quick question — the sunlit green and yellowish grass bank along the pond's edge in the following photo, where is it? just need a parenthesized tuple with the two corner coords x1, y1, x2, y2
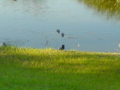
(0, 47, 120, 90)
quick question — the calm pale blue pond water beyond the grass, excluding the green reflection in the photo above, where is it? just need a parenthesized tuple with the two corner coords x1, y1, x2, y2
(0, 0, 120, 52)
